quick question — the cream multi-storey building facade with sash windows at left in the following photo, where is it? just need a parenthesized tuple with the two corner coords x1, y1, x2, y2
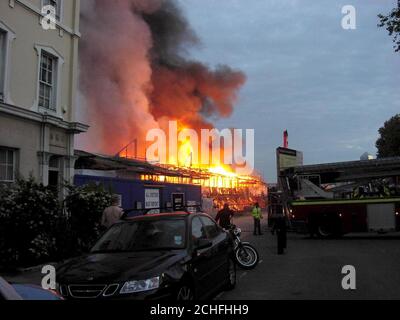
(0, 0, 88, 185)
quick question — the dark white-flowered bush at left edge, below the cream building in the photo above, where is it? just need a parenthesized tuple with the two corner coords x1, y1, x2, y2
(0, 178, 61, 268)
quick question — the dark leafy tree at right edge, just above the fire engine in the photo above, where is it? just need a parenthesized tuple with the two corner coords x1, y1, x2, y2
(376, 114, 400, 158)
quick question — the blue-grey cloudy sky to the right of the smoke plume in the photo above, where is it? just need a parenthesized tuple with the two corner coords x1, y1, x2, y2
(179, 0, 400, 182)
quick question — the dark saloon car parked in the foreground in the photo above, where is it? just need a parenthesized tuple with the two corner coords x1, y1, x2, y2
(57, 212, 236, 300)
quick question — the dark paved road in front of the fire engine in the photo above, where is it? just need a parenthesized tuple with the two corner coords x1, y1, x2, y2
(218, 212, 400, 300)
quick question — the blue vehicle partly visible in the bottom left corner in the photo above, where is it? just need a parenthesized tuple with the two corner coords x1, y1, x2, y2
(0, 277, 63, 301)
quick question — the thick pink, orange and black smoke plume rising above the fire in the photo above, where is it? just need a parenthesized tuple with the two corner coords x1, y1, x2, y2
(80, 0, 245, 157)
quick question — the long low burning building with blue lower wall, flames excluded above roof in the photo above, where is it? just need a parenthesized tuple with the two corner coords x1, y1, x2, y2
(75, 151, 267, 214)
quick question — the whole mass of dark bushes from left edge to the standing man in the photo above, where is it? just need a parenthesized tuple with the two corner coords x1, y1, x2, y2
(0, 178, 112, 270)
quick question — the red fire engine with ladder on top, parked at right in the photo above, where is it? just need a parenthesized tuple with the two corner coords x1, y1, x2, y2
(279, 158, 400, 237)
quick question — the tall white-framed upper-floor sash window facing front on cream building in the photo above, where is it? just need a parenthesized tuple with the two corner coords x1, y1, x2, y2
(39, 51, 57, 111)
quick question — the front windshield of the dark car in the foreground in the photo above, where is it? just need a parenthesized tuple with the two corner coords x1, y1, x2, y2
(91, 218, 186, 253)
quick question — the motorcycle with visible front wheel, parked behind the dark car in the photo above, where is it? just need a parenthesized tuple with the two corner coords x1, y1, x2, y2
(228, 225, 260, 270)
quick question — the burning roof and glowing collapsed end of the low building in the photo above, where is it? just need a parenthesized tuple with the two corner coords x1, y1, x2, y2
(75, 151, 268, 210)
